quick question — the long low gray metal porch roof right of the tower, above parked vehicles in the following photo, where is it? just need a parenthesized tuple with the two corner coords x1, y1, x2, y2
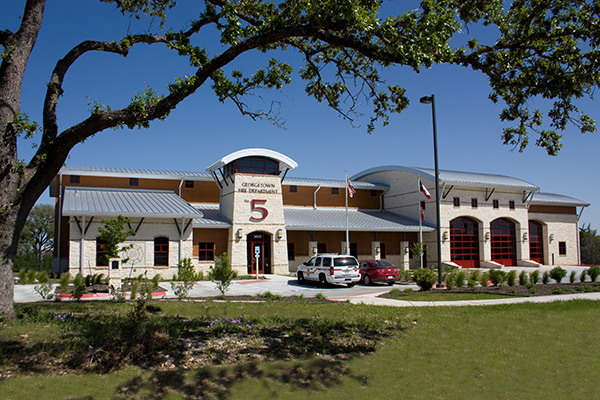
(284, 207, 434, 232)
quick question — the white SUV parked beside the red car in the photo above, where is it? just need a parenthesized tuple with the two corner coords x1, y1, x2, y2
(296, 254, 360, 287)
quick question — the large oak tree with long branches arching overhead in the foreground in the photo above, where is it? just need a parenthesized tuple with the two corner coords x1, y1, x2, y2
(0, 0, 600, 319)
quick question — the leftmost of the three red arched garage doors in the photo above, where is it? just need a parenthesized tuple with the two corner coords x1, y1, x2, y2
(450, 217, 479, 268)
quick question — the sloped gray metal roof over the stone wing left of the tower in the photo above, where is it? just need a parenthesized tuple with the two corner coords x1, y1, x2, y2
(62, 187, 202, 218)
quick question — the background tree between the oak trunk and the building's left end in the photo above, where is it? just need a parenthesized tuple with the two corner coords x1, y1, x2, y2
(14, 204, 54, 272)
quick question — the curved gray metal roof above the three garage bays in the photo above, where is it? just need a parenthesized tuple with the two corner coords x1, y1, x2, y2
(351, 165, 540, 191)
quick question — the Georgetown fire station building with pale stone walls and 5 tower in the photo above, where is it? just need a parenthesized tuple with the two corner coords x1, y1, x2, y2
(50, 149, 589, 277)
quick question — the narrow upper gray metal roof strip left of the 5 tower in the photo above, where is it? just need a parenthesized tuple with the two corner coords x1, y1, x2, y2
(60, 166, 213, 181)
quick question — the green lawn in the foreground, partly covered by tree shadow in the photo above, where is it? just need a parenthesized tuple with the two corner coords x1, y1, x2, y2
(0, 301, 600, 400)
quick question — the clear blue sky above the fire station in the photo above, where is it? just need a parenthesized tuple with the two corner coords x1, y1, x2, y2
(5, 0, 600, 229)
